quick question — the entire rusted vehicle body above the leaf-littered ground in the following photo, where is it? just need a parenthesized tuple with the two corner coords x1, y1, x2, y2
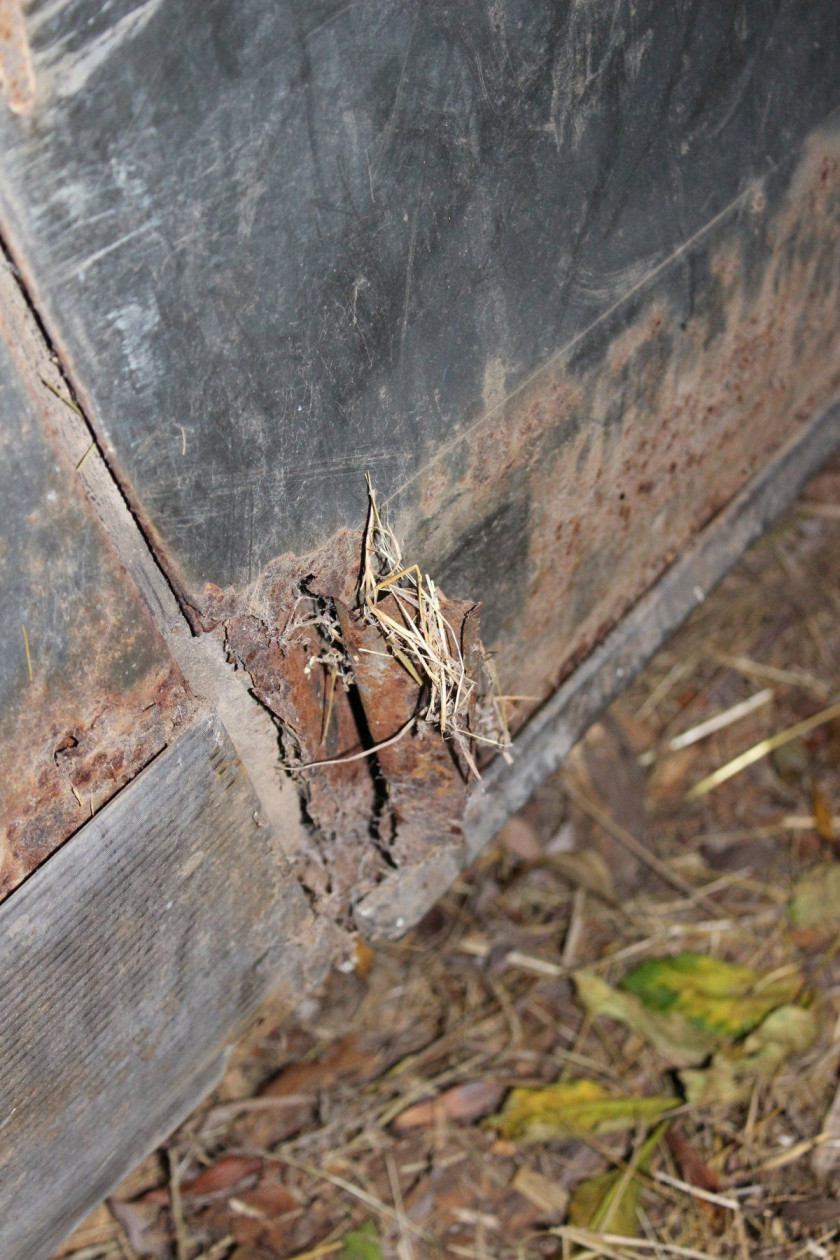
(0, 0, 840, 1260)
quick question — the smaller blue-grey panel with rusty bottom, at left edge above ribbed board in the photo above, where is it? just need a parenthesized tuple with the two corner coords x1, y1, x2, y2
(0, 312, 193, 900)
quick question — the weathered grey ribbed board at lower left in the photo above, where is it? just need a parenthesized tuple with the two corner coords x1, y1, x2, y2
(0, 716, 319, 1260)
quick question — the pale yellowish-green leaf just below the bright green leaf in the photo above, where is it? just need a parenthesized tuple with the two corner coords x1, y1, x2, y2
(680, 1005, 820, 1103)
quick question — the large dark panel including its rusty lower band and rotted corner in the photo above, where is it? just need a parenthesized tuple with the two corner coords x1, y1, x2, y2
(0, 0, 840, 924)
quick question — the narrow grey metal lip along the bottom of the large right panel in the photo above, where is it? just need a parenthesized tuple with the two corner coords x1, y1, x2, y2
(356, 402, 840, 939)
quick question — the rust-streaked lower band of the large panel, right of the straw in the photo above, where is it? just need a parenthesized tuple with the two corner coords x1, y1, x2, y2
(395, 120, 840, 726)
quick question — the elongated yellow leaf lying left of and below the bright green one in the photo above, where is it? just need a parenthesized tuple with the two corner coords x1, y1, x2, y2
(489, 1080, 680, 1142)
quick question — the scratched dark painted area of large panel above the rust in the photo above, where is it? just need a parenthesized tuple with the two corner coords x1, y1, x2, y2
(0, 0, 840, 599)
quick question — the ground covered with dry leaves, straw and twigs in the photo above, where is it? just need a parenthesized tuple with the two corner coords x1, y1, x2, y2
(57, 464, 840, 1260)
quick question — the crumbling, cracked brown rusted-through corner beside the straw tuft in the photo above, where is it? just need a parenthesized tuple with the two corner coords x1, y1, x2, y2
(203, 530, 479, 922)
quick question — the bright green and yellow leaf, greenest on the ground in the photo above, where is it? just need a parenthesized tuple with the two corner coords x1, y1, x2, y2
(620, 950, 802, 1041)
